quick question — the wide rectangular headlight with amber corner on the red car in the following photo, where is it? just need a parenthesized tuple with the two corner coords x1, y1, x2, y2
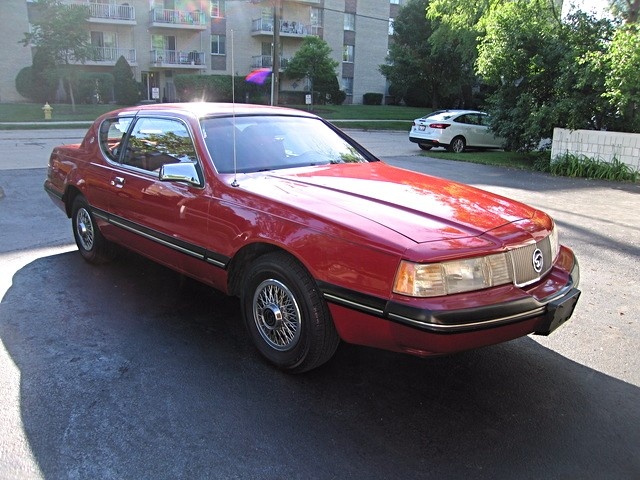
(393, 253, 513, 297)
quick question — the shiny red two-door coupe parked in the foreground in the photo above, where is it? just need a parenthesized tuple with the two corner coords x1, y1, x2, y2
(45, 103, 580, 372)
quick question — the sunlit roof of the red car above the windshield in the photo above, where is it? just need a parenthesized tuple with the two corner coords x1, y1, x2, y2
(112, 102, 317, 118)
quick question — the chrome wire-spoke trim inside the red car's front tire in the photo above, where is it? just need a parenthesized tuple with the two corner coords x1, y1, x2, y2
(253, 278, 302, 352)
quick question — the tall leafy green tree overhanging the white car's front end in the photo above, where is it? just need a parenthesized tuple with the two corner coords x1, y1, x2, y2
(477, 1, 565, 150)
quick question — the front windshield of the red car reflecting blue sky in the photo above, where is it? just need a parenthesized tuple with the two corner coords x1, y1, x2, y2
(201, 115, 368, 173)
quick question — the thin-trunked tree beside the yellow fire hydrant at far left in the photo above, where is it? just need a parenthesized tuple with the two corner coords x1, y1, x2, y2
(22, 0, 91, 111)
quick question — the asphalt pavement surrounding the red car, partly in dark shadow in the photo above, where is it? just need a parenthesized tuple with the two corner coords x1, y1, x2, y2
(0, 129, 640, 479)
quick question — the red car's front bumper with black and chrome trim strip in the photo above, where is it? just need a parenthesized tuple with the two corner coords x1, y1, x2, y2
(323, 247, 581, 355)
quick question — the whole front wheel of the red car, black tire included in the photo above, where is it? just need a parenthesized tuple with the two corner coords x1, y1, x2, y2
(241, 252, 340, 373)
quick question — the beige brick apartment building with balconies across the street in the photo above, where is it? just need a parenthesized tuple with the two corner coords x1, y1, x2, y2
(0, 0, 406, 103)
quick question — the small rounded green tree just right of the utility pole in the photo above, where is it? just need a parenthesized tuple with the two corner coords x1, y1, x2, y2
(284, 37, 338, 106)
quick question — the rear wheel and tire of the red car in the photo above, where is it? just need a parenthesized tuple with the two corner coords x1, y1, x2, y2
(71, 195, 115, 264)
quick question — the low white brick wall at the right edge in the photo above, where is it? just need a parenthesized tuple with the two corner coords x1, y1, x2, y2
(551, 128, 640, 170)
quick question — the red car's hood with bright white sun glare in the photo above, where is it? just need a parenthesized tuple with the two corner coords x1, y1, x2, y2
(242, 162, 536, 243)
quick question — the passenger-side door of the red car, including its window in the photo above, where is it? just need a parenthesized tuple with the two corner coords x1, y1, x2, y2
(109, 117, 209, 270)
